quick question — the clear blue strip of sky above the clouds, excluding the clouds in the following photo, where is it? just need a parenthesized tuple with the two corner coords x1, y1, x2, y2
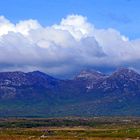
(0, 0, 140, 39)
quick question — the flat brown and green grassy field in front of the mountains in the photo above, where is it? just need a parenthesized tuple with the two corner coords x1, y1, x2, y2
(0, 117, 140, 140)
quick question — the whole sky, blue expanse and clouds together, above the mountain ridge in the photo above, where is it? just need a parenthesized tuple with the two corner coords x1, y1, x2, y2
(0, 0, 140, 78)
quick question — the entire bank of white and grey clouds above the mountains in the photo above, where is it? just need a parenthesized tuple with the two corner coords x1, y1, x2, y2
(0, 15, 140, 76)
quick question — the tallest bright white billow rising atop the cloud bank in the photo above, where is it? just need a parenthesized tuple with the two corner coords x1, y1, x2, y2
(53, 15, 94, 40)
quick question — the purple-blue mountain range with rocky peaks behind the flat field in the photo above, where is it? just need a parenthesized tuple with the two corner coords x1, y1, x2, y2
(0, 68, 140, 117)
